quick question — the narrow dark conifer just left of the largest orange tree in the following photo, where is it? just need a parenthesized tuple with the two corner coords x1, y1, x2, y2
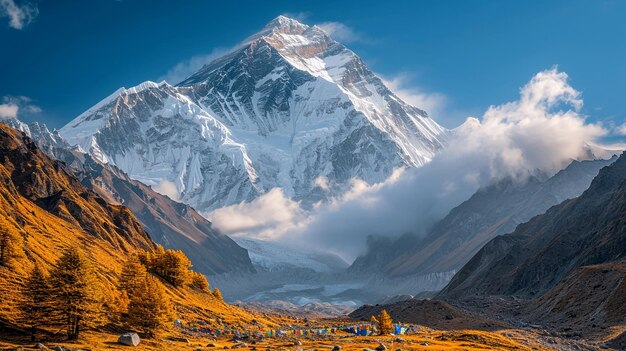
(20, 264, 51, 340)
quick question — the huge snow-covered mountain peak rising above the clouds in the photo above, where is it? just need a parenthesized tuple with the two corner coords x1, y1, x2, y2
(60, 16, 448, 211)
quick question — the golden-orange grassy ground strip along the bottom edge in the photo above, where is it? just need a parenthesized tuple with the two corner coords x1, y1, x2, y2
(0, 327, 616, 351)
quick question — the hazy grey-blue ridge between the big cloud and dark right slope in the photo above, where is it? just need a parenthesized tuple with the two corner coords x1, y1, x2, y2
(350, 157, 617, 277)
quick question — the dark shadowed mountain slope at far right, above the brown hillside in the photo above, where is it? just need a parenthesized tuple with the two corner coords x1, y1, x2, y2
(439, 154, 626, 299)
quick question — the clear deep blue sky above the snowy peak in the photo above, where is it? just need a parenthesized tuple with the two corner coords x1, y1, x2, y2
(0, 0, 626, 132)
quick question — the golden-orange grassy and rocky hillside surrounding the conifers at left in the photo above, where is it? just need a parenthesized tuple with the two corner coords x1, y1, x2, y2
(0, 123, 274, 329)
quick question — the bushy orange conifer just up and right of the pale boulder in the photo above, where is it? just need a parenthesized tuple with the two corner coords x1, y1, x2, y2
(128, 275, 172, 337)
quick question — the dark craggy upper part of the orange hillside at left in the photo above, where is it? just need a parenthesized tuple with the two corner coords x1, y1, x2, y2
(0, 124, 154, 251)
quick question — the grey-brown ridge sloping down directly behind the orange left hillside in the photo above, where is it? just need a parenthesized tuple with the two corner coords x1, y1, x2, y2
(2, 119, 254, 275)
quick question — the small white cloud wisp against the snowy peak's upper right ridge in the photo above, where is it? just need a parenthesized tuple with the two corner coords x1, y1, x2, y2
(383, 74, 447, 118)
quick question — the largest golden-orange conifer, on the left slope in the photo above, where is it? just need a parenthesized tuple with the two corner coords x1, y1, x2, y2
(50, 249, 104, 340)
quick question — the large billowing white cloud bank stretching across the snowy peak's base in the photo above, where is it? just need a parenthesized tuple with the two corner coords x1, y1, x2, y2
(210, 69, 606, 260)
